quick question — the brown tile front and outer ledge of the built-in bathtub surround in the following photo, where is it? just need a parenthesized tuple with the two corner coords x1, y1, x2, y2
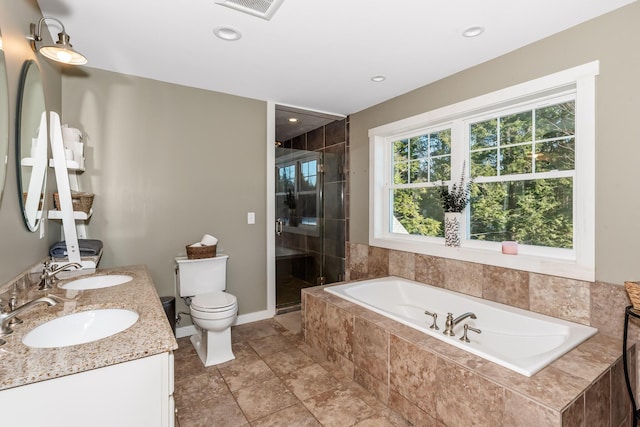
(302, 287, 636, 427)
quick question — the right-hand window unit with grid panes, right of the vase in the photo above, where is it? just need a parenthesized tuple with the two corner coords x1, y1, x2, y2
(465, 98, 575, 249)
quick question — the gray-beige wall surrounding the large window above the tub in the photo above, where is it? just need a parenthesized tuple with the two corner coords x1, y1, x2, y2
(349, 2, 640, 284)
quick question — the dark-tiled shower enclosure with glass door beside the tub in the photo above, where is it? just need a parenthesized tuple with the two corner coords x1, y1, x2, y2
(275, 113, 346, 313)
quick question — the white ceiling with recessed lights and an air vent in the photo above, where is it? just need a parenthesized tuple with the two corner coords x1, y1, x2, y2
(38, 0, 635, 118)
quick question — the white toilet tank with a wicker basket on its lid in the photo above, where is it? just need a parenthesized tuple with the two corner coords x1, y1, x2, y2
(176, 253, 229, 297)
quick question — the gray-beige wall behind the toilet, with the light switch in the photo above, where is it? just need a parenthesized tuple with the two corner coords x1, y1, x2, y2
(62, 68, 267, 314)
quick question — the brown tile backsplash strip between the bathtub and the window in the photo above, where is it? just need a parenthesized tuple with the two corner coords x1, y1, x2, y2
(346, 242, 640, 388)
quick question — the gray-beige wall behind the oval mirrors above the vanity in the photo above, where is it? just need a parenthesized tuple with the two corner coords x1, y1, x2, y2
(0, 0, 61, 285)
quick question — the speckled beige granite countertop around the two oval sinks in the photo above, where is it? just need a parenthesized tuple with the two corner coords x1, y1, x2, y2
(0, 265, 178, 390)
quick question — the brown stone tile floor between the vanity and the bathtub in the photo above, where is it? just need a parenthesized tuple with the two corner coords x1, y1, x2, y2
(174, 312, 408, 427)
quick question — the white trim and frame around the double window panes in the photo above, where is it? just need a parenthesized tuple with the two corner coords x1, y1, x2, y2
(369, 61, 600, 281)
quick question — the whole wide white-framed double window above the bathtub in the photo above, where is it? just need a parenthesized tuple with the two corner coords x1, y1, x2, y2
(369, 62, 598, 280)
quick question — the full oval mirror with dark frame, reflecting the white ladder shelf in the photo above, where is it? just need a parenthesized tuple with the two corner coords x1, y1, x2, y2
(16, 60, 48, 231)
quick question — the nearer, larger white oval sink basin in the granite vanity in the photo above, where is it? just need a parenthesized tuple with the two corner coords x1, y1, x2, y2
(22, 308, 138, 348)
